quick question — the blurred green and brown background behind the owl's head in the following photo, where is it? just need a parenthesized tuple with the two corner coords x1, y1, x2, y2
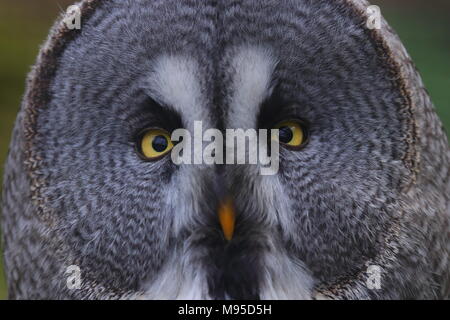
(0, 0, 450, 299)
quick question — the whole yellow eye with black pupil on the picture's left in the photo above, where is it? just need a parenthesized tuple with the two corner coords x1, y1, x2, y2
(139, 129, 173, 160)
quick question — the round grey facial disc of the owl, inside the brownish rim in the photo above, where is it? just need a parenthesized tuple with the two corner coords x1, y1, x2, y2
(18, 0, 418, 299)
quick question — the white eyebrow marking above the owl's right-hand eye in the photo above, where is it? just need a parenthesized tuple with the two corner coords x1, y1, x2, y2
(228, 46, 277, 129)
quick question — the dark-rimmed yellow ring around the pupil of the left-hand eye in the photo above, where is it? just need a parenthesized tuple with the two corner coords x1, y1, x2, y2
(135, 127, 174, 162)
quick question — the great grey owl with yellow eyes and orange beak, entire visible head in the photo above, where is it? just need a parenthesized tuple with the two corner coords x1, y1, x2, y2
(2, 0, 450, 299)
